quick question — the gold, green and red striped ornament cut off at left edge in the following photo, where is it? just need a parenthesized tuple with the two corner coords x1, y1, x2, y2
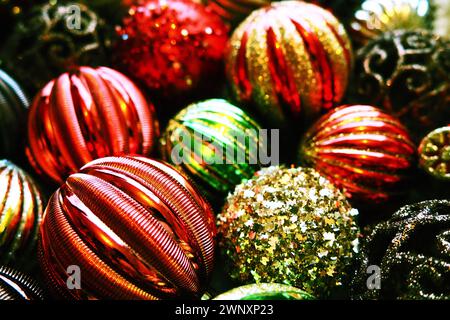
(0, 160, 44, 270)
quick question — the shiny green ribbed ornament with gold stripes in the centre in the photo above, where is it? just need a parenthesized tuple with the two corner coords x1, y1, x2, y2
(161, 99, 263, 200)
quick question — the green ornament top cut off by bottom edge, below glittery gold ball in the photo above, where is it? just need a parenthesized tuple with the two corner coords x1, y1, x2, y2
(214, 283, 314, 300)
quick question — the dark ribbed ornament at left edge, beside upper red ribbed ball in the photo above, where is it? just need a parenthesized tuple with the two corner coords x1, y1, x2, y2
(0, 70, 29, 158)
